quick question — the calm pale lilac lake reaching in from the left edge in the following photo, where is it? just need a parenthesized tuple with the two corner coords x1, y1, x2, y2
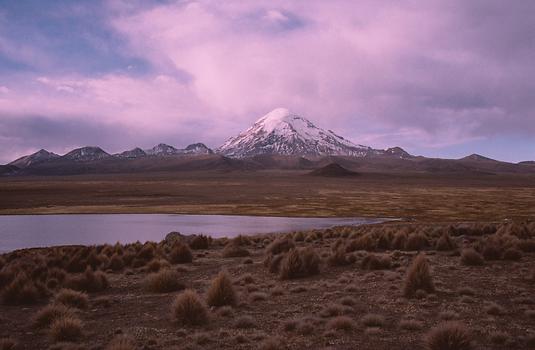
(0, 214, 388, 252)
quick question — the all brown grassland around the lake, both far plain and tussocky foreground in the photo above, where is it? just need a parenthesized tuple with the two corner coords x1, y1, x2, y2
(0, 171, 535, 350)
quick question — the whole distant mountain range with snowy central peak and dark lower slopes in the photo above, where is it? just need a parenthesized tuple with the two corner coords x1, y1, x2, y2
(0, 108, 535, 175)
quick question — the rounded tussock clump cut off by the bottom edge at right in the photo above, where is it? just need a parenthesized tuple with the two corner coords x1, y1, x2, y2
(425, 322, 473, 350)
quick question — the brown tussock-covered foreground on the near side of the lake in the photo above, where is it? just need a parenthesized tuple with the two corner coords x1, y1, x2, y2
(0, 221, 535, 350)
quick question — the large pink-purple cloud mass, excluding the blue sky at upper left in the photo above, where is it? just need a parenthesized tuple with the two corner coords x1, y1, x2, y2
(0, 1, 535, 163)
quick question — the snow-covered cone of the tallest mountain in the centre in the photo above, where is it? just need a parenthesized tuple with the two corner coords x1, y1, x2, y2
(218, 108, 371, 158)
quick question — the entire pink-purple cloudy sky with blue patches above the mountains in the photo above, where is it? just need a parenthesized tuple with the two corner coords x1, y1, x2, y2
(0, 0, 535, 163)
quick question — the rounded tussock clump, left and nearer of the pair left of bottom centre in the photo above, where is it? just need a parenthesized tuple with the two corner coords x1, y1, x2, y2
(172, 289, 208, 326)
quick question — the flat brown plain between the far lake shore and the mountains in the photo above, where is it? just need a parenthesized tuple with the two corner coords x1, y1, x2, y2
(0, 171, 535, 221)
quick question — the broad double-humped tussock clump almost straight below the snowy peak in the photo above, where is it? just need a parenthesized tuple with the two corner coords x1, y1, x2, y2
(279, 247, 320, 279)
